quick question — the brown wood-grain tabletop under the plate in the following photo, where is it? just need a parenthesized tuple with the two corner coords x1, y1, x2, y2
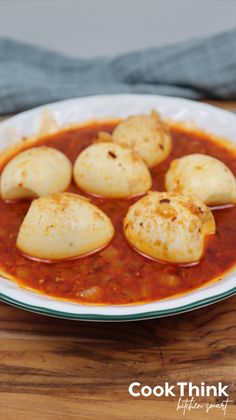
(0, 103, 236, 420)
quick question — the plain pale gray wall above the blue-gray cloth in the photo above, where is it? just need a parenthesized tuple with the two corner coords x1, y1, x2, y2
(0, 0, 236, 56)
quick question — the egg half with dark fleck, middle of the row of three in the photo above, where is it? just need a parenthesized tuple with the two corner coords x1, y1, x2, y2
(73, 142, 152, 198)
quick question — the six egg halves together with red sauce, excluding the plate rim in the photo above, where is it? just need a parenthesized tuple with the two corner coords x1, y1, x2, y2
(0, 111, 236, 305)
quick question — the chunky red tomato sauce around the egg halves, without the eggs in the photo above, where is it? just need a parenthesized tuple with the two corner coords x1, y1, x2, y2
(0, 122, 236, 304)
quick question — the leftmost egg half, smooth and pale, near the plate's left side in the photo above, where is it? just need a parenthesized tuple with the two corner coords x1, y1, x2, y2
(0, 146, 72, 201)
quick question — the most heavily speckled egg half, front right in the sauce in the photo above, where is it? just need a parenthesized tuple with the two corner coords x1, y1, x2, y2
(124, 192, 215, 264)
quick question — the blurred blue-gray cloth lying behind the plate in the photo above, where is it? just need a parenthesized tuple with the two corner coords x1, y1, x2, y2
(0, 28, 236, 114)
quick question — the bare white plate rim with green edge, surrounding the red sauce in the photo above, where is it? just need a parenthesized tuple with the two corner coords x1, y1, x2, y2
(0, 95, 236, 321)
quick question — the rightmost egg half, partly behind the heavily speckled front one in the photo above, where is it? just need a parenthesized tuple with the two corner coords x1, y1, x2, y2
(165, 153, 236, 206)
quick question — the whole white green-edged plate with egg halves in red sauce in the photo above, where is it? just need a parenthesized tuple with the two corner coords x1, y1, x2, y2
(0, 94, 236, 321)
